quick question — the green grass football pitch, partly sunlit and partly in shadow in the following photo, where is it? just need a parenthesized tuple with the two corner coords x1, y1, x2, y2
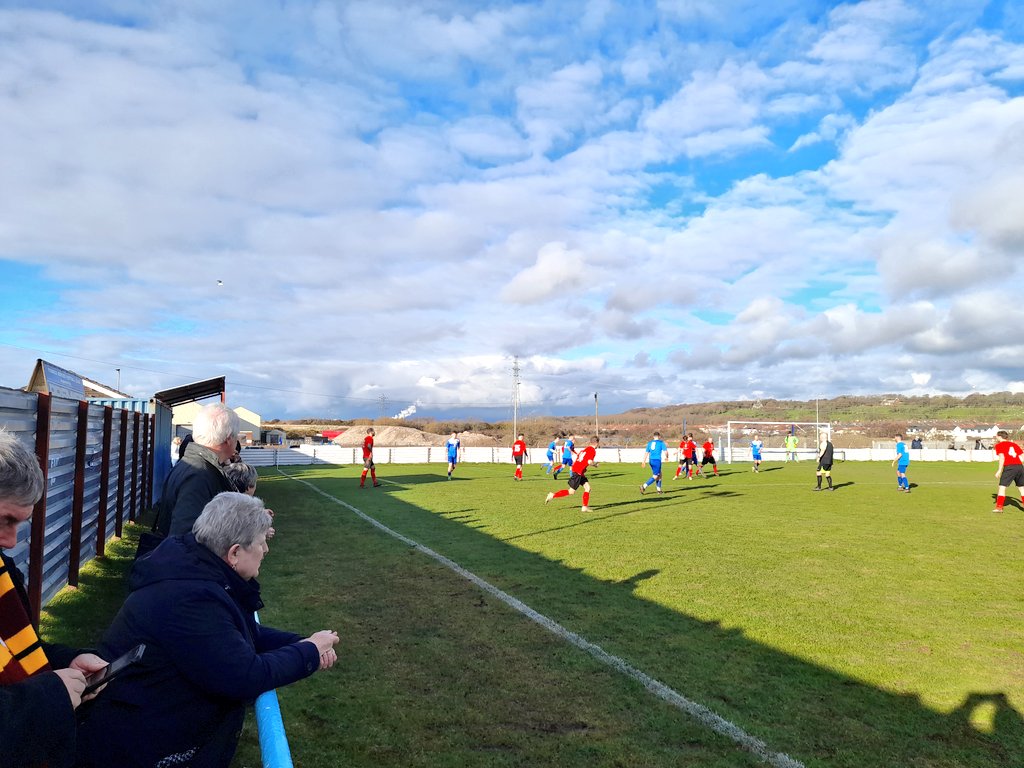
(41, 462, 1024, 768)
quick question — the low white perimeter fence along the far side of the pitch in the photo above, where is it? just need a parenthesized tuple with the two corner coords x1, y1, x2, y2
(242, 445, 995, 467)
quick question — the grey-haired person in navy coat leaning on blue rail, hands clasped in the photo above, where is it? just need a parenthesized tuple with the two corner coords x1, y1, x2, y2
(79, 493, 338, 768)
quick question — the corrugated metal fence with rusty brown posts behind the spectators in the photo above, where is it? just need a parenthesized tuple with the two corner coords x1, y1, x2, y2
(0, 387, 155, 620)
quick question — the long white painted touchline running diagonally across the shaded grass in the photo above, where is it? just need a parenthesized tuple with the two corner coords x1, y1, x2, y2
(276, 467, 804, 768)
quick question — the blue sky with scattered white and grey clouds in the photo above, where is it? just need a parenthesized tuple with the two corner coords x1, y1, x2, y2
(0, 0, 1024, 420)
